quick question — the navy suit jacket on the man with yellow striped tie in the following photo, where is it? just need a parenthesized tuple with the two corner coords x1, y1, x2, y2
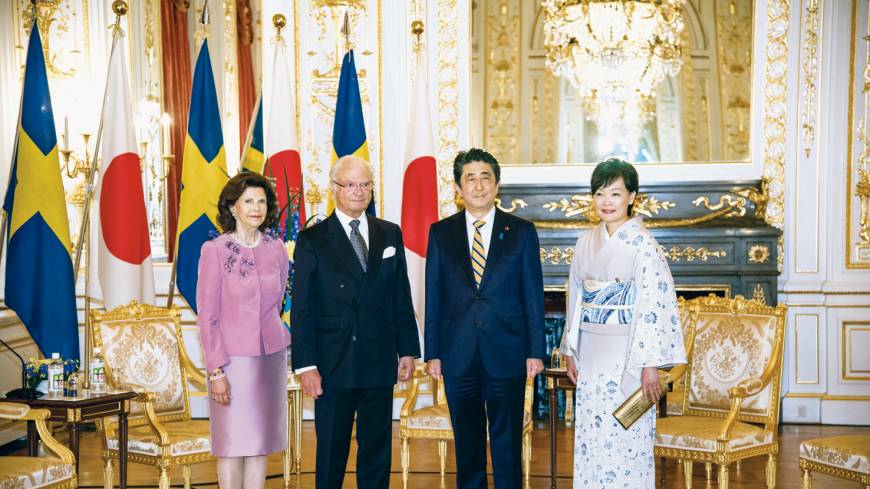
(424, 209, 545, 378)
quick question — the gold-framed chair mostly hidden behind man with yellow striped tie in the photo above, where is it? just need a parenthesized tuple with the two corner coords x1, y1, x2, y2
(399, 363, 534, 489)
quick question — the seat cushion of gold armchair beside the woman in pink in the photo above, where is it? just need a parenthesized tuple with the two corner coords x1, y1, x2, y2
(108, 420, 211, 457)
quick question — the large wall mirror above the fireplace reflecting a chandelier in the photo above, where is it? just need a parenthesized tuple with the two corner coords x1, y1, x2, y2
(471, 0, 754, 164)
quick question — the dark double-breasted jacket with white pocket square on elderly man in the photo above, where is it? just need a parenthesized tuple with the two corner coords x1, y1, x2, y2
(290, 213, 420, 389)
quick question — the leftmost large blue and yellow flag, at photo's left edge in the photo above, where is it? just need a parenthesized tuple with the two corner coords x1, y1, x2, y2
(3, 22, 79, 359)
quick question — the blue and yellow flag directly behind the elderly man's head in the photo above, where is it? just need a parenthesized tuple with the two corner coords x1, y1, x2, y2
(329, 49, 375, 215)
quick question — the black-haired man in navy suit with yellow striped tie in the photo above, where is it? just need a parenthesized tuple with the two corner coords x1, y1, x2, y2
(425, 148, 545, 489)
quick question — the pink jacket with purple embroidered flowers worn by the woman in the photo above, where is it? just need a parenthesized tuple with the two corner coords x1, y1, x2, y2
(196, 233, 290, 371)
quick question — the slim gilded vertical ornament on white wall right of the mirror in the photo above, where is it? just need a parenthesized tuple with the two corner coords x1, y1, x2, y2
(800, 0, 824, 158)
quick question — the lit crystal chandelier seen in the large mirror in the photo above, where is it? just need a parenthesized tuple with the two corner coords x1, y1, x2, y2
(542, 0, 685, 133)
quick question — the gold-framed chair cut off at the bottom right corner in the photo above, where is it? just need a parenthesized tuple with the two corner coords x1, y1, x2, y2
(798, 435, 870, 489)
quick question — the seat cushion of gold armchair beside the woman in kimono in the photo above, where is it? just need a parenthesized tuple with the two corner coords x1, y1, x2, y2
(656, 416, 773, 452)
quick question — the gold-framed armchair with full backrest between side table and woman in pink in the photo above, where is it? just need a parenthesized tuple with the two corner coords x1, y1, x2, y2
(91, 301, 212, 489)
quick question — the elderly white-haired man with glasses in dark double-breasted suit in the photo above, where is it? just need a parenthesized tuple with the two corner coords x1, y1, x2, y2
(291, 156, 420, 489)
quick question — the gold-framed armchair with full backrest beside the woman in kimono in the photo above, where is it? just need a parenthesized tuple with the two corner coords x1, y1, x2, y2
(655, 295, 786, 489)
